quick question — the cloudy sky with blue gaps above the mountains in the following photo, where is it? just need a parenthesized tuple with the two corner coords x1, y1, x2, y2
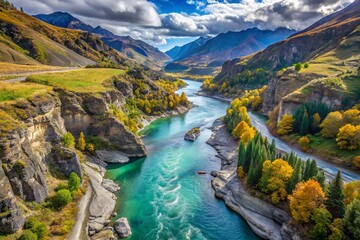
(10, 0, 353, 50)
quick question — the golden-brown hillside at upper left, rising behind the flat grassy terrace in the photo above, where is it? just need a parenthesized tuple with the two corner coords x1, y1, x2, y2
(0, 4, 126, 66)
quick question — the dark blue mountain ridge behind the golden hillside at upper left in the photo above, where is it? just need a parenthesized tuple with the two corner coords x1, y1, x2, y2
(35, 12, 170, 69)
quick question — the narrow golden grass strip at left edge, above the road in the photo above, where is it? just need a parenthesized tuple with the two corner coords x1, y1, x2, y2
(0, 62, 59, 75)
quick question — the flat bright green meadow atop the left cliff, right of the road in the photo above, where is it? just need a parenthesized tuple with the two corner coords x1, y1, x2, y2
(26, 68, 124, 92)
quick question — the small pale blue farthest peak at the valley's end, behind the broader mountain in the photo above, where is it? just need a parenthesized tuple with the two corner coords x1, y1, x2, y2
(166, 36, 211, 60)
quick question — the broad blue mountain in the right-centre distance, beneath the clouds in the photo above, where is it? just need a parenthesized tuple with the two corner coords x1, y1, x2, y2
(165, 28, 295, 74)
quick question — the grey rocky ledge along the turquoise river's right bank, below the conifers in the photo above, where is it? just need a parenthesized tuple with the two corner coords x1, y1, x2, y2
(207, 120, 300, 240)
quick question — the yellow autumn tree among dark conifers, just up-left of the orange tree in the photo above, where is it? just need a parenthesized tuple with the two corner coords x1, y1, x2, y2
(260, 158, 294, 204)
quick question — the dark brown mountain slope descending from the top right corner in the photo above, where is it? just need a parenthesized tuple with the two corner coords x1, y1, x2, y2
(217, 0, 360, 79)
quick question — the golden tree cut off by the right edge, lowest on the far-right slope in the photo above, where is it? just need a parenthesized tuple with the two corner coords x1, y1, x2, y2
(336, 124, 360, 150)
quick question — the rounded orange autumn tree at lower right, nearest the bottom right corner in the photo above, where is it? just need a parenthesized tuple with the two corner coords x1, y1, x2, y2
(289, 179, 325, 222)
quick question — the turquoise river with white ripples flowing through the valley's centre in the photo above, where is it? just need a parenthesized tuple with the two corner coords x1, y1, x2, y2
(107, 81, 258, 240)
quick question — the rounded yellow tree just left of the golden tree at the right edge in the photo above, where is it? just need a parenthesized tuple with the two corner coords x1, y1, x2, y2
(320, 111, 344, 138)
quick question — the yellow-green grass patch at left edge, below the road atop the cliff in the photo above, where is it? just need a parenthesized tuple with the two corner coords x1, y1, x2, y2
(0, 82, 51, 102)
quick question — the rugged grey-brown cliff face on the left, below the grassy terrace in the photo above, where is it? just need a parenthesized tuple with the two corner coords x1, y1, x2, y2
(0, 82, 146, 233)
